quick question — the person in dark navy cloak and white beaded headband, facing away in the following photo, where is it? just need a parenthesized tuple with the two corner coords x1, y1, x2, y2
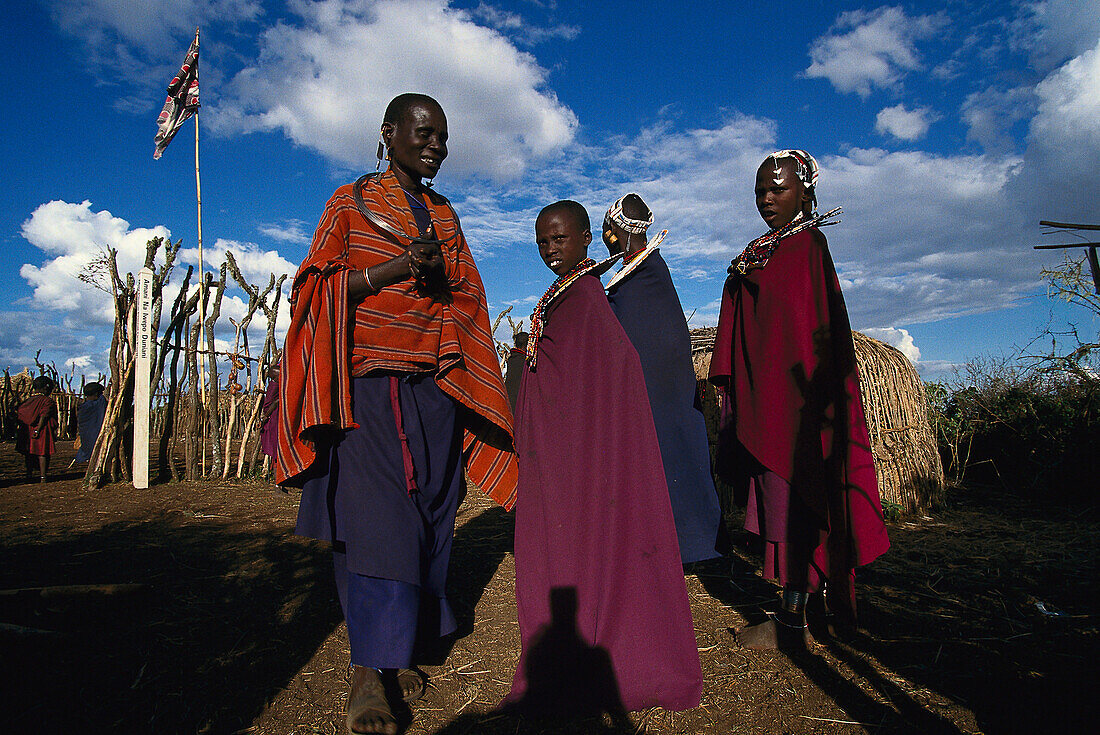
(603, 194, 727, 564)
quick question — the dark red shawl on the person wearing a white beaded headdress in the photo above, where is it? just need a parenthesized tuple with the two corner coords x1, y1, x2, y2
(710, 229, 890, 566)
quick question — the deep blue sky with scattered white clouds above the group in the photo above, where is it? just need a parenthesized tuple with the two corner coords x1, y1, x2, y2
(0, 0, 1100, 379)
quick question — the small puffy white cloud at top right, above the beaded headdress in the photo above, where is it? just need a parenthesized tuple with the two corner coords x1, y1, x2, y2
(804, 7, 945, 98)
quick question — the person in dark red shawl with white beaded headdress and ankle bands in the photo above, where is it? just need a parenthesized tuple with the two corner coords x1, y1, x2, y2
(710, 151, 890, 649)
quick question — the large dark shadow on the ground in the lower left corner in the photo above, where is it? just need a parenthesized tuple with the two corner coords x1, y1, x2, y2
(0, 512, 340, 733)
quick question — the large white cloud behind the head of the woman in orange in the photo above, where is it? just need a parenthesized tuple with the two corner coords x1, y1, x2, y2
(211, 0, 578, 180)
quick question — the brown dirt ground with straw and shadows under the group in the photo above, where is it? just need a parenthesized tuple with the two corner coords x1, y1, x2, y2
(0, 443, 1100, 735)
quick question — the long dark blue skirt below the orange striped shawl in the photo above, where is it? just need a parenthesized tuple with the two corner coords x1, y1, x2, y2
(295, 375, 465, 668)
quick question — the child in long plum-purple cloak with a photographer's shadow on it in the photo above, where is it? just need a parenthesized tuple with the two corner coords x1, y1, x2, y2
(508, 201, 702, 716)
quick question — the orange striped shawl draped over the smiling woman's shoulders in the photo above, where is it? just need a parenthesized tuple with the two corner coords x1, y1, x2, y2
(275, 171, 518, 508)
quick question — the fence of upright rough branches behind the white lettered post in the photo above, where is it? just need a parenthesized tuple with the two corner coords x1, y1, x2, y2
(58, 238, 286, 487)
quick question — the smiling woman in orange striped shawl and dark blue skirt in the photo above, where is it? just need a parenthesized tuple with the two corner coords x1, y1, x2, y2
(276, 95, 517, 733)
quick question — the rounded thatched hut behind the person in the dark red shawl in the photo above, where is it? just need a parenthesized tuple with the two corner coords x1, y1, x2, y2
(691, 327, 944, 513)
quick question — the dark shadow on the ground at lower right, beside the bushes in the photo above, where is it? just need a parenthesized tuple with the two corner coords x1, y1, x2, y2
(696, 491, 1100, 734)
